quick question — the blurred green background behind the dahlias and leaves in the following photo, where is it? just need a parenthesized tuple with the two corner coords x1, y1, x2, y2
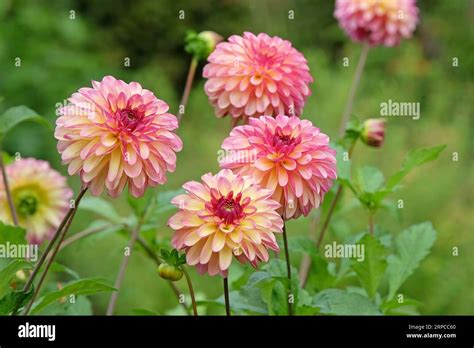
(0, 0, 474, 314)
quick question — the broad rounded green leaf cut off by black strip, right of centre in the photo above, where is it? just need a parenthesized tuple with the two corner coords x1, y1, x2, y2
(314, 289, 381, 315)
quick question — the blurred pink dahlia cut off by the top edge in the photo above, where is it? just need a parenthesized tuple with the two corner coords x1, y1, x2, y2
(334, 0, 418, 46)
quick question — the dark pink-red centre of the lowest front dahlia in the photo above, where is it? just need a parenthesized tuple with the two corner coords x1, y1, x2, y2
(209, 189, 250, 225)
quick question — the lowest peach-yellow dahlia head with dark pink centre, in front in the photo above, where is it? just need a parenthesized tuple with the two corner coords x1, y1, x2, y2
(168, 170, 283, 277)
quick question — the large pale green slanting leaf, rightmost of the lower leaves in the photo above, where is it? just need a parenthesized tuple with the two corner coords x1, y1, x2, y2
(387, 222, 436, 299)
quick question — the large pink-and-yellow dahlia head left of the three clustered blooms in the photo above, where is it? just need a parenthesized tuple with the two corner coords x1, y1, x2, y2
(55, 76, 182, 197)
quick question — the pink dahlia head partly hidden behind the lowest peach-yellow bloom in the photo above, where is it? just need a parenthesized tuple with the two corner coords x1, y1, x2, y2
(220, 115, 337, 220)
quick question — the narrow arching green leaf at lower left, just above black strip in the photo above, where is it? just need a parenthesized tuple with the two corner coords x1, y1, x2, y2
(31, 279, 117, 314)
